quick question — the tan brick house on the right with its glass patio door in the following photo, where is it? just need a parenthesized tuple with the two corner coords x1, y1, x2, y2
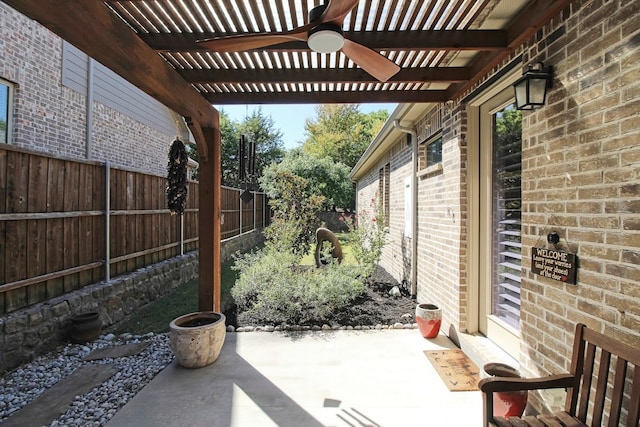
(351, 1, 640, 416)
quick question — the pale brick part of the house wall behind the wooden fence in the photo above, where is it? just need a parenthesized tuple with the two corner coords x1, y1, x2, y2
(0, 3, 175, 176)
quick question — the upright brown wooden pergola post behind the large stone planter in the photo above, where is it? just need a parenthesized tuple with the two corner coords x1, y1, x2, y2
(198, 119, 222, 312)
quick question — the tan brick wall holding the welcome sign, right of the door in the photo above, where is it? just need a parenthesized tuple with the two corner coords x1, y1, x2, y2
(521, 0, 640, 414)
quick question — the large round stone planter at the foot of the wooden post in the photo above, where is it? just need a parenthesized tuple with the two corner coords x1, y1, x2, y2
(169, 311, 227, 368)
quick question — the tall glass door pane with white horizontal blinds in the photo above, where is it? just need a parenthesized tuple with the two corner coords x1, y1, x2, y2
(492, 105, 522, 329)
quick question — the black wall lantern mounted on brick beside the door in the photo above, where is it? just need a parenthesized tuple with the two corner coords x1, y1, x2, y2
(513, 62, 553, 110)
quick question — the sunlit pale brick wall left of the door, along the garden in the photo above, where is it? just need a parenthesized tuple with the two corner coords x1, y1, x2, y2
(357, 115, 467, 331)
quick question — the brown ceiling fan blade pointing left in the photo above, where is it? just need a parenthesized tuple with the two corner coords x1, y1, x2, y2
(198, 24, 313, 52)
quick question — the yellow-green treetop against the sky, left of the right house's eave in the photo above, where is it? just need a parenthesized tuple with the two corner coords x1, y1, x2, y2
(302, 104, 389, 169)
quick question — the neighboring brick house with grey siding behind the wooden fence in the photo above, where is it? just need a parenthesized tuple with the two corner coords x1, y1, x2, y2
(0, 3, 189, 175)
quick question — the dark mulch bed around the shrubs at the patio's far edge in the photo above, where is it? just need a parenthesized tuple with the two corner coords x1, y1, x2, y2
(224, 267, 416, 326)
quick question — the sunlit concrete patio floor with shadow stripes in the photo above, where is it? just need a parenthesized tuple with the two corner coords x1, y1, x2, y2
(107, 329, 482, 427)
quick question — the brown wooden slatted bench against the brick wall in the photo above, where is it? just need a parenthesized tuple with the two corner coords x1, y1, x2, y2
(478, 324, 640, 427)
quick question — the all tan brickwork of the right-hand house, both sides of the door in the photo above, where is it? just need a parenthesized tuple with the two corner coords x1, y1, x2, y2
(358, 0, 640, 418)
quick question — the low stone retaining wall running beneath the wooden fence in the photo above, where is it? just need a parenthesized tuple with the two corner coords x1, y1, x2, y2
(0, 230, 263, 372)
